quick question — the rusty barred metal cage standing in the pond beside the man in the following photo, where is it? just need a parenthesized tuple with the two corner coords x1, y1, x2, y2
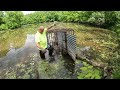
(47, 28, 76, 60)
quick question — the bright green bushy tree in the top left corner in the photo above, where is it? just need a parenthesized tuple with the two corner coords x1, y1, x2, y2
(0, 11, 23, 30)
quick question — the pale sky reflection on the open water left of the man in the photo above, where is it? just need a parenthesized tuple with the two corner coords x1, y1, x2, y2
(0, 34, 38, 70)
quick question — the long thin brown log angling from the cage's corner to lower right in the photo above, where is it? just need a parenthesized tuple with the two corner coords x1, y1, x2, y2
(76, 47, 114, 79)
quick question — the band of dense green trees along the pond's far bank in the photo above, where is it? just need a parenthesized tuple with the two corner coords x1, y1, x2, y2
(0, 11, 120, 41)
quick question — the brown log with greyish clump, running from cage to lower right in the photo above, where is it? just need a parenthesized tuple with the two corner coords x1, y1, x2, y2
(76, 47, 114, 79)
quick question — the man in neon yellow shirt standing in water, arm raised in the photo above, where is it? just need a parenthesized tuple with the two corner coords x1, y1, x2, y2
(35, 23, 56, 59)
